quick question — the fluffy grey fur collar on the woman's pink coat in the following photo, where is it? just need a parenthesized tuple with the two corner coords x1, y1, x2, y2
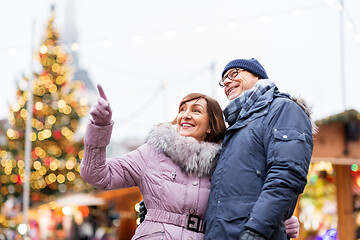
(146, 123, 221, 176)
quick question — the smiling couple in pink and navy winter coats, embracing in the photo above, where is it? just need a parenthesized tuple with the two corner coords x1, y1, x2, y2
(81, 58, 313, 240)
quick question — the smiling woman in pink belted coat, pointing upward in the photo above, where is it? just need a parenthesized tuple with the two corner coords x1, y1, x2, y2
(81, 85, 297, 239)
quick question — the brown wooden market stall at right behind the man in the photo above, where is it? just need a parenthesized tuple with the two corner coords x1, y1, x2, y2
(299, 110, 360, 240)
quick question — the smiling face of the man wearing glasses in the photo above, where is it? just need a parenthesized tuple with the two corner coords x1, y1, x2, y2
(224, 68, 260, 100)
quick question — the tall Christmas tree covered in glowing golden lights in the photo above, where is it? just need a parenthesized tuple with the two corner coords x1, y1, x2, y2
(0, 9, 88, 212)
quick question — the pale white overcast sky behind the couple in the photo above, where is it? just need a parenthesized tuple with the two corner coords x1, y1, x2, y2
(0, 0, 360, 139)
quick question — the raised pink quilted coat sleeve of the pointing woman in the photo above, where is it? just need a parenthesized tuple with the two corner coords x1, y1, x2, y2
(80, 123, 148, 190)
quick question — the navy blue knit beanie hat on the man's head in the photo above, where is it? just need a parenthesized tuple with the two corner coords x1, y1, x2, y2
(221, 58, 269, 79)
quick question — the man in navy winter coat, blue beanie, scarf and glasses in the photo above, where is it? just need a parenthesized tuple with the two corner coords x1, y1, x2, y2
(205, 58, 313, 240)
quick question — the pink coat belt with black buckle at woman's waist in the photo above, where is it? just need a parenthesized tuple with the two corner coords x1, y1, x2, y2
(145, 209, 204, 233)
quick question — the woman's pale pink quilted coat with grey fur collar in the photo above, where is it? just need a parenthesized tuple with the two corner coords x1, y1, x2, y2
(81, 124, 220, 239)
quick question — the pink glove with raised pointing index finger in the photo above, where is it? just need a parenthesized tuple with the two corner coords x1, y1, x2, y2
(90, 84, 112, 126)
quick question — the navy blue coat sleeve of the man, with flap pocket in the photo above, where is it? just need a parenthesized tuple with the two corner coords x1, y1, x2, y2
(245, 100, 313, 236)
